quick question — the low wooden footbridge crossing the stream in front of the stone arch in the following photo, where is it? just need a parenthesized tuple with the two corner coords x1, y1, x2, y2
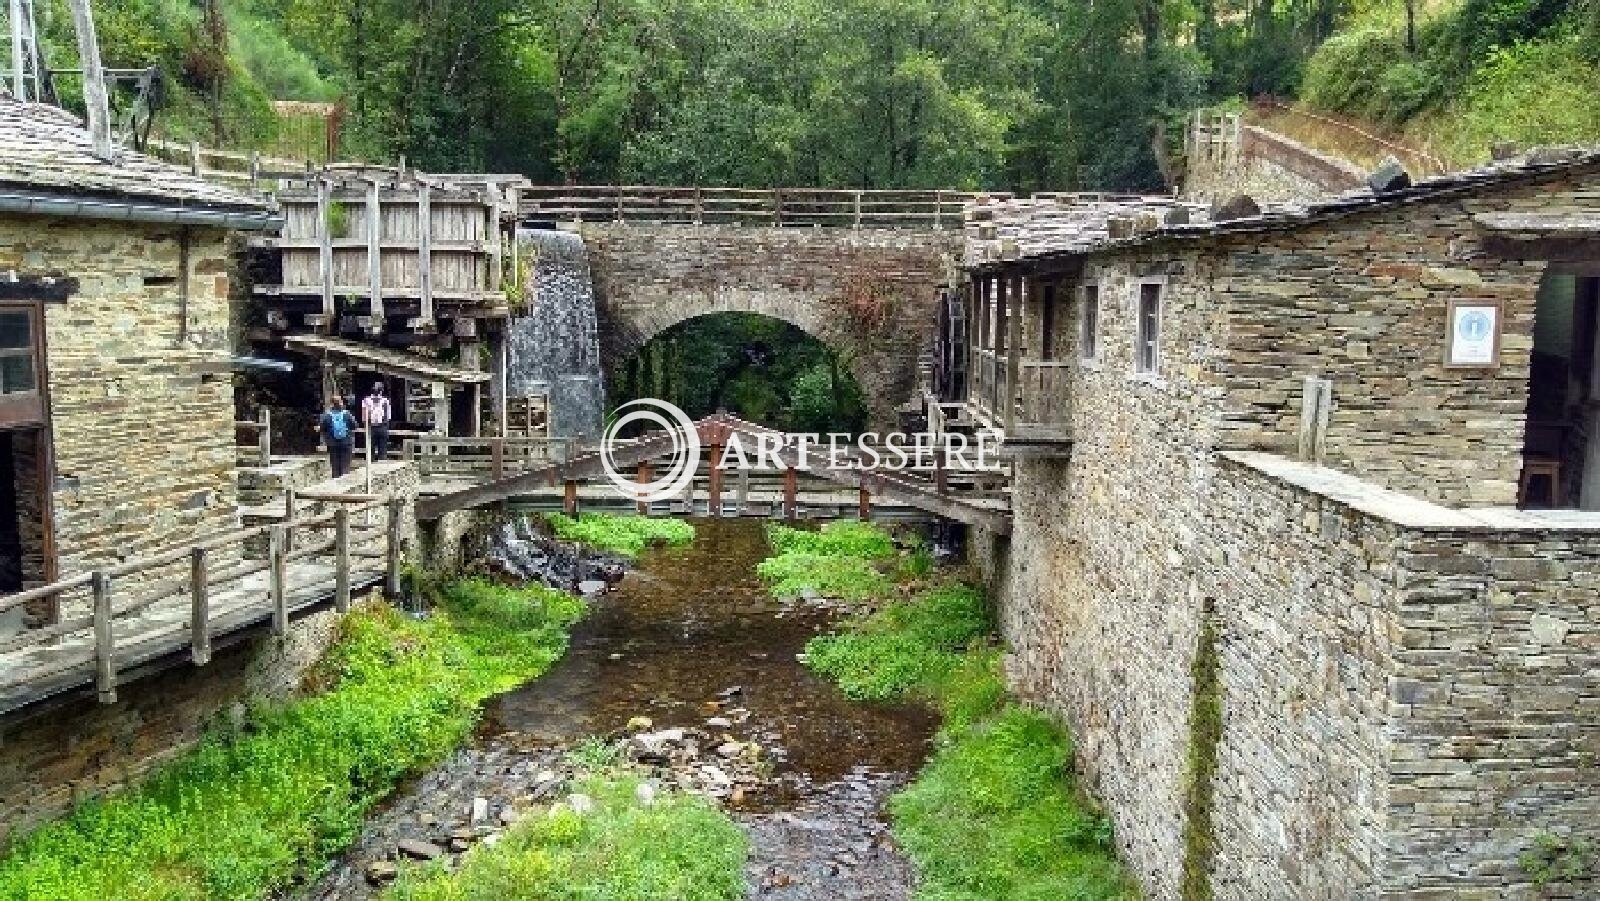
(406, 413, 1011, 533)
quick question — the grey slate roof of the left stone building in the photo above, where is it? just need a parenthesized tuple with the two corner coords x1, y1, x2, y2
(0, 98, 270, 213)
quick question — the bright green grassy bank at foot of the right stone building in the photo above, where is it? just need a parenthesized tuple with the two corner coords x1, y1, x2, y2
(793, 521, 1136, 901)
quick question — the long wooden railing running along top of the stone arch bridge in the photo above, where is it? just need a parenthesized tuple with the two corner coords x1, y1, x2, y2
(522, 186, 1010, 229)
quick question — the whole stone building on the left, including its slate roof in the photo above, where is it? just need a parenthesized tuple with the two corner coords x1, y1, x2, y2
(0, 98, 275, 631)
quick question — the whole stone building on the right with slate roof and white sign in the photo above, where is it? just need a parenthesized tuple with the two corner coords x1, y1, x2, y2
(938, 152, 1600, 899)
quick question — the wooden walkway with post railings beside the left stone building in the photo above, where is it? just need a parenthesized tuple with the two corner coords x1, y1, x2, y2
(0, 495, 403, 709)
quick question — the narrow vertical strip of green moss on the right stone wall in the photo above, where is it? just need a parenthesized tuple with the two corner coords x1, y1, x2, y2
(1179, 599, 1222, 901)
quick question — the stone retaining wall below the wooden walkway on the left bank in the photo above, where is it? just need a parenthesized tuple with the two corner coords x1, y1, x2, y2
(0, 611, 347, 847)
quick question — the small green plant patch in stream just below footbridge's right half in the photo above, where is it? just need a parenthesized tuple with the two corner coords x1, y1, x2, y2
(755, 520, 894, 600)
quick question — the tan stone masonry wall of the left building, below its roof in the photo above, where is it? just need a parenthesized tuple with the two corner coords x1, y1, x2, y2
(0, 216, 235, 575)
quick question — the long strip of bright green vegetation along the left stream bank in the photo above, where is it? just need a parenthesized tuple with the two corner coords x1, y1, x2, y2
(0, 579, 584, 901)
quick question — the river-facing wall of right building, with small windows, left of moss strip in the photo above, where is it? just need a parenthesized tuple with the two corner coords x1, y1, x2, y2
(1000, 243, 1224, 898)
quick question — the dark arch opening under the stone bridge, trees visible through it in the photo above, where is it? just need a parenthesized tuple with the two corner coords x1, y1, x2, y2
(606, 312, 869, 434)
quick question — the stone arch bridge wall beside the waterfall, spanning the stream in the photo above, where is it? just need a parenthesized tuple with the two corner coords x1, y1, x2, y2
(581, 222, 962, 424)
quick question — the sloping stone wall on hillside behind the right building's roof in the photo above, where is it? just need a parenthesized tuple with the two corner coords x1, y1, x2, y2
(1182, 125, 1365, 203)
